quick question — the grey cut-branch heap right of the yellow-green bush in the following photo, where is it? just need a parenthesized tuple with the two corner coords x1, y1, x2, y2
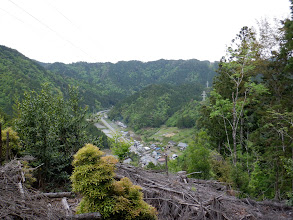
(116, 164, 293, 220)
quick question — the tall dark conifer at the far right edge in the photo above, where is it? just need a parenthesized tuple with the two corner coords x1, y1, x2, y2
(250, 1, 293, 199)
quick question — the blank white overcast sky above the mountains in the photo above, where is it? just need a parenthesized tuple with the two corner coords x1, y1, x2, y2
(0, 0, 290, 63)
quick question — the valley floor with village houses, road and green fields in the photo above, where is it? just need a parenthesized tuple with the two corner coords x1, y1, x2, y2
(95, 110, 189, 167)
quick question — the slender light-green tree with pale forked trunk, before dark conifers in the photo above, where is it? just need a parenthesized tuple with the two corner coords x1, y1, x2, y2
(211, 27, 267, 166)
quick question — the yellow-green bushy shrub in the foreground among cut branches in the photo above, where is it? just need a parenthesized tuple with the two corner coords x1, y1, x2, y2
(71, 144, 157, 220)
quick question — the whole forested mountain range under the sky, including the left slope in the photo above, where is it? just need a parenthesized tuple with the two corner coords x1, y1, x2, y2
(0, 46, 217, 117)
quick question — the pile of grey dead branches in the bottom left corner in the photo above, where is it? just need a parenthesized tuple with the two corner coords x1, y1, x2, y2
(0, 160, 62, 220)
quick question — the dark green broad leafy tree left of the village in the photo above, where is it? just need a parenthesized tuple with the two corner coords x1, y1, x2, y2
(15, 84, 86, 184)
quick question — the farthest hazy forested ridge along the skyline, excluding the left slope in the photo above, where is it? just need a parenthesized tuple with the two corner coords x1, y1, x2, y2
(44, 60, 218, 110)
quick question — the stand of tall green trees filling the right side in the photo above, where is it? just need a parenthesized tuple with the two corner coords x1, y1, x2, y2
(197, 13, 293, 201)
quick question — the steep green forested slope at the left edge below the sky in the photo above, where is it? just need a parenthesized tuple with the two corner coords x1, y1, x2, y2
(0, 46, 57, 115)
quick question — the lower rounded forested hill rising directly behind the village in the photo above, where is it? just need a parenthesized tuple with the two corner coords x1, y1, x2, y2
(109, 83, 203, 129)
